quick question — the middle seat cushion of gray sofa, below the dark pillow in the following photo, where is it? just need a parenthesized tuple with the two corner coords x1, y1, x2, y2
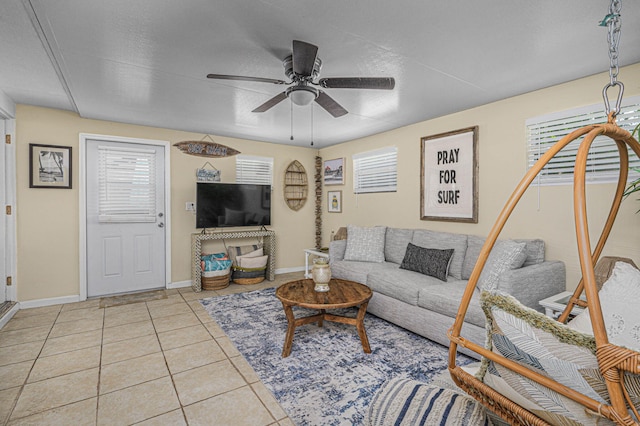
(366, 262, 440, 305)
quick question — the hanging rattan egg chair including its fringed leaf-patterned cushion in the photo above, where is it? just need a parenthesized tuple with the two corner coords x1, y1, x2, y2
(449, 113, 640, 425)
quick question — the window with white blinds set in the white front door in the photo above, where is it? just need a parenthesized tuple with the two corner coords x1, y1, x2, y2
(98, 146, 157, 222)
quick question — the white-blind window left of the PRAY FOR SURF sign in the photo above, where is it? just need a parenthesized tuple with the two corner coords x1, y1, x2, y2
(353, 146, 398, 194)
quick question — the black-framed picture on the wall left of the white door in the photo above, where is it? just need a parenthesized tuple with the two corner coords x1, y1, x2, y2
(29, 143, 71, 189)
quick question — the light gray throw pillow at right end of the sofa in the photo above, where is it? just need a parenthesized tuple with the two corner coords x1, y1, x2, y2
(477, 240, 527, 291)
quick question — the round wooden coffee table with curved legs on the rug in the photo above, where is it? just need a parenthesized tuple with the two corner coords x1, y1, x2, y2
(276, 279, 372, 358)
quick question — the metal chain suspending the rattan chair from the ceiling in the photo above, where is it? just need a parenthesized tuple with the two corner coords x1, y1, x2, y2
(600, 0, 624, 117)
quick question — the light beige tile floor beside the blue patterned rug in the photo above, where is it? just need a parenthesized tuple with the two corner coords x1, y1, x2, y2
(0, 272, 302, 425)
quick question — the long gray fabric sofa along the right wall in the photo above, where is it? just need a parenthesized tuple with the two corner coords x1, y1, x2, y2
(329, 225, 566, 356)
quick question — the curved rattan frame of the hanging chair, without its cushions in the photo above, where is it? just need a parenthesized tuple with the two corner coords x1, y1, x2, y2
(448, 114, 640, 425)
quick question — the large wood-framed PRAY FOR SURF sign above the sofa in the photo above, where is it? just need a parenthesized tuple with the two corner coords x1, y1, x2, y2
(420, 126, 478, 223)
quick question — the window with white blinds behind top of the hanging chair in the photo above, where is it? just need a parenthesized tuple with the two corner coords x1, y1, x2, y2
(526, 96, 640, 185)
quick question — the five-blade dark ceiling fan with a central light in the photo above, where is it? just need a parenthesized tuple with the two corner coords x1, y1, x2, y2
(207, 40, 395, 118)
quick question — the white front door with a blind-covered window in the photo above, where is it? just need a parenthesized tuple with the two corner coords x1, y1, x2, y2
(86, 139, 166, 297)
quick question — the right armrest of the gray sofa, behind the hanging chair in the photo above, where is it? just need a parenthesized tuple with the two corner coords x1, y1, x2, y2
(498, 260, 567, 312)
